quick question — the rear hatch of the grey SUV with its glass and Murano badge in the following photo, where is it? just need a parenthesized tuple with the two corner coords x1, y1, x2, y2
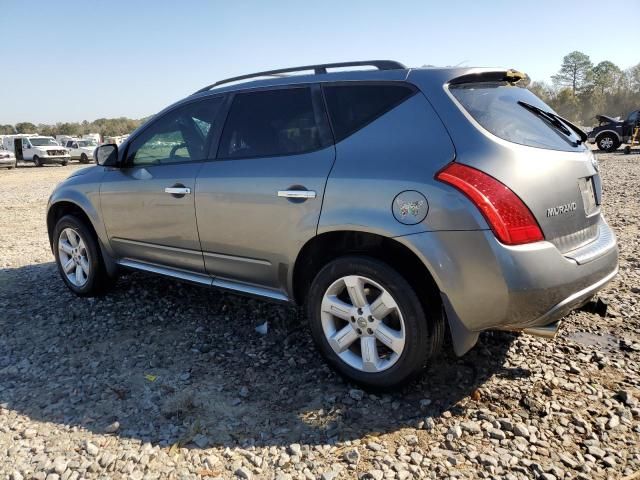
(448, 76, 601, 253)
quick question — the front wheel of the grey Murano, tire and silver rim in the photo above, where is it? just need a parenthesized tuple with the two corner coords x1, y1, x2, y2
(53, 215, 115, 297)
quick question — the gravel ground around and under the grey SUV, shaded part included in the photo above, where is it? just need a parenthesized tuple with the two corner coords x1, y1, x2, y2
(0, 154, 640, 480)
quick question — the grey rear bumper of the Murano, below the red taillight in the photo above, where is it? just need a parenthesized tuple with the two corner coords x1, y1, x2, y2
(398, 219, 618, 353)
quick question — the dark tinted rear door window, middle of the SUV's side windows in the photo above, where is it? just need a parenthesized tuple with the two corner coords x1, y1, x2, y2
(218, 87, 324, 159)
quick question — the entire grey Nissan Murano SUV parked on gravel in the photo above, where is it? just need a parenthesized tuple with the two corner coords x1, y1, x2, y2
(47, 61, 618, 388)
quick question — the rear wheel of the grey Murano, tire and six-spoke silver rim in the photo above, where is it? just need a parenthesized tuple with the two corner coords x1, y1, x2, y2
(307, 256, 444, 391)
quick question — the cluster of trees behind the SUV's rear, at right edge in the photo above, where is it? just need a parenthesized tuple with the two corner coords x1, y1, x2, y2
(526, 51, 640, 126)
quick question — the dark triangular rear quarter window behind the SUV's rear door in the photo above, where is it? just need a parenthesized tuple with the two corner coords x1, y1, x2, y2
(323, 83, 414, 142)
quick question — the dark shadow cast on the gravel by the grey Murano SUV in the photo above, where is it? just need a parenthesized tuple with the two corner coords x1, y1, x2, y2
(0, 263, 529, 448)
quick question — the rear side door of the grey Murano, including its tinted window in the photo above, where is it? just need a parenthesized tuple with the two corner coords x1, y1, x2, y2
(195, 85, 335, 296)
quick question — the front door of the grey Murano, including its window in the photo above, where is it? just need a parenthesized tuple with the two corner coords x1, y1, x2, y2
(100, 97, 222, 274)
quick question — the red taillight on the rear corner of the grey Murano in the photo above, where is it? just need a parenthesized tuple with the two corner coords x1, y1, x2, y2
(436, 163, 544, 245)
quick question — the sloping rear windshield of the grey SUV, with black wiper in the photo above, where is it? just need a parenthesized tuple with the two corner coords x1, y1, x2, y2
(449, 82, 585, 151)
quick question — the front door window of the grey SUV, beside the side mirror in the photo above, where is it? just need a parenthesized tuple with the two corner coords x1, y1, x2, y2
(127, 97, 222, 166)
